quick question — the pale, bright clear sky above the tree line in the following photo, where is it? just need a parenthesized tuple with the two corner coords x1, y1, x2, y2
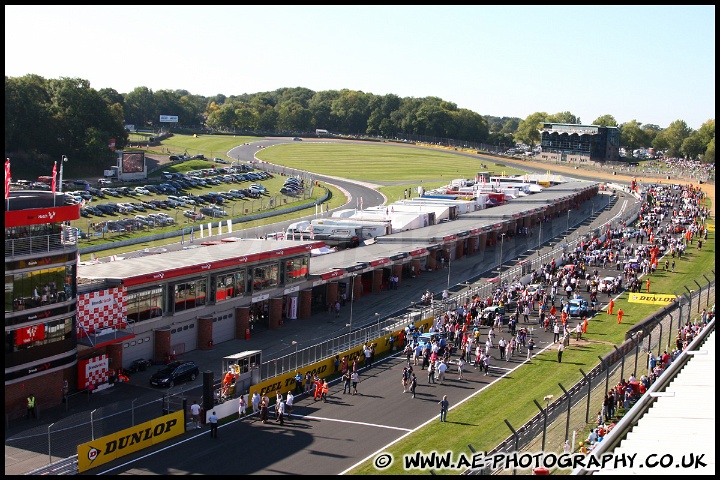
(5, 5, 715, 130)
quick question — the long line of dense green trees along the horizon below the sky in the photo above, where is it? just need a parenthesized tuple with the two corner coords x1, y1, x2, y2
(5, 74, 715, 177)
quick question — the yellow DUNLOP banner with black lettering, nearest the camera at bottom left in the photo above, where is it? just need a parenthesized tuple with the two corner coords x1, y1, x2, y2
(78, 411, 185, 472)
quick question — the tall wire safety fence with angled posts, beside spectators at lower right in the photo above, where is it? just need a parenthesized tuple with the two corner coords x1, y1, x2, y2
(464, 279, 715, 475)
